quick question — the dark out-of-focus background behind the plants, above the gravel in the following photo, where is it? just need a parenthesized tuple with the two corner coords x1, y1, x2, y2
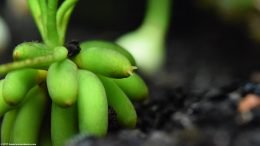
(0, 0, 260, 89)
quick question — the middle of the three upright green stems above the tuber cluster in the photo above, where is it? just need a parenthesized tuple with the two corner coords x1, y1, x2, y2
(46, 0, 60, 48)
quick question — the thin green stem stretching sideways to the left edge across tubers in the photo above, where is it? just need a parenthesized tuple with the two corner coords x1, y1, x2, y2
(0, 47, 68, 74)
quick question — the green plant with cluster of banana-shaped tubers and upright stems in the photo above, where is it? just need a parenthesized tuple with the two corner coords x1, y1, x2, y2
(0, 0, 148, 146)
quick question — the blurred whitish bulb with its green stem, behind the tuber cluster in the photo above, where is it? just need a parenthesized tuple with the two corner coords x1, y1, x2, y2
(116, 0, 172, 75)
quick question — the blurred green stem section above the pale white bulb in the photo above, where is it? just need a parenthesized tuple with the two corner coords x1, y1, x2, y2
(140, 0, 172, 34)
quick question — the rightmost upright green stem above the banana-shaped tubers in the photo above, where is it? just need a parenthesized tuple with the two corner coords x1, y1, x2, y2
(56, 0, 78, 44)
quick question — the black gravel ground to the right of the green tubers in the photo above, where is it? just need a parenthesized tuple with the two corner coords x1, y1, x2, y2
(65, 82, 260, 146)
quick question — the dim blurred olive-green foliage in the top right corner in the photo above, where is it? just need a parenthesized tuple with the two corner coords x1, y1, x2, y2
(197, 0, 260, 43)
